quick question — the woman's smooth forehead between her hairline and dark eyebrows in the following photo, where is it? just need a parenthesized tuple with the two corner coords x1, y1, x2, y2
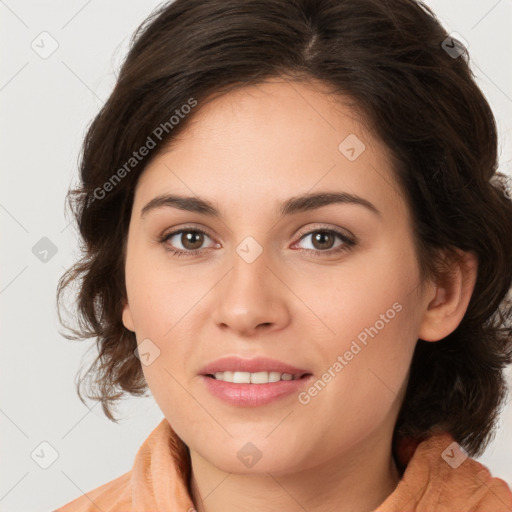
(136, 80, 406, 219)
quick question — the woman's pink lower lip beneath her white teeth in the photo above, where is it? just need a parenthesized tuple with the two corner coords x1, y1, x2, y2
(201, 375, 312, 407)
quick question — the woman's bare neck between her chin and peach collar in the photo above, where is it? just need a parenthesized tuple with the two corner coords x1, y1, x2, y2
(191, 432, 400, 512)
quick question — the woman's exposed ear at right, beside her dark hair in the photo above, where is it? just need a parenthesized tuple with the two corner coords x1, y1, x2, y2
(418, 249, 478, 341)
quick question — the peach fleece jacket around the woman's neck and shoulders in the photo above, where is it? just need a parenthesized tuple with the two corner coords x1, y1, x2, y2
(54, 418, 512, 512)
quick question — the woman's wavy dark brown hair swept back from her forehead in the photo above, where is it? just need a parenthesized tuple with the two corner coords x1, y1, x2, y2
(57, 0, 512, 455)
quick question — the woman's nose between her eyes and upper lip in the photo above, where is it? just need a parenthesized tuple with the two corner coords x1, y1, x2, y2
(213, 252, 290, 337)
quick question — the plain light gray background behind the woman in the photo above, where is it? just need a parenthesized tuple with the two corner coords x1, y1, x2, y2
(0, 0, 512, 512)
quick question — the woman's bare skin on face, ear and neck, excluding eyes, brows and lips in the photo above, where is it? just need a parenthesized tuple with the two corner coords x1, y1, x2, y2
(123, 80, 476, 512)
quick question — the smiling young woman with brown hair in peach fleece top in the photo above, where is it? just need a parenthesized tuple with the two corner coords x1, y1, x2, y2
(55, 0, 512, 512)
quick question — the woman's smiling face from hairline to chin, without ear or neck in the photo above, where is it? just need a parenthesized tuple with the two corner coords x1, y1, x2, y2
(123, 81, 427, 474)
